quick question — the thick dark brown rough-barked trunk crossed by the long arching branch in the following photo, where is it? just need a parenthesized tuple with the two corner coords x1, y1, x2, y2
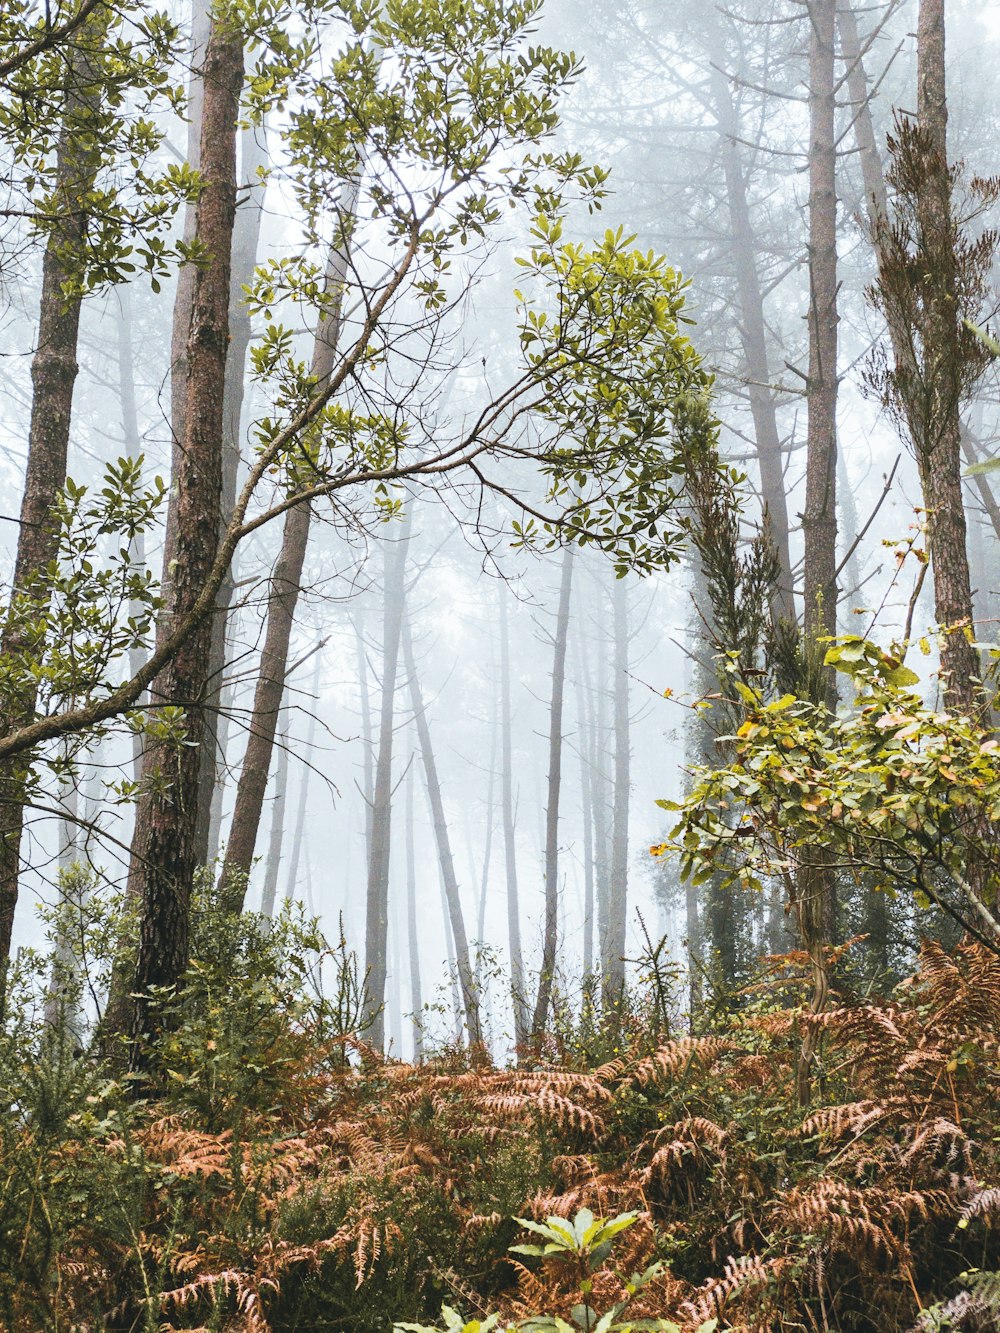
(129, 20, 243, 1068)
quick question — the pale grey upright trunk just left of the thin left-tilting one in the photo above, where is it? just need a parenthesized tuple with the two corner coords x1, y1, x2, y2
(364, 514, 413, 1049)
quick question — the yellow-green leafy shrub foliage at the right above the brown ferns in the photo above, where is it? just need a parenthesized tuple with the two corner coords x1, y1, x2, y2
(656, 637, 1000, 946)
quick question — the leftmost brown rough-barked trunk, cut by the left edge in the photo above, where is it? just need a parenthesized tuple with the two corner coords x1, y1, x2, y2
(0, 20, 107, 975)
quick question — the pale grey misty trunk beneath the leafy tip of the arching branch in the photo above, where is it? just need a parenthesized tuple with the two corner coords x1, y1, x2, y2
(603, 579, 632, 1021)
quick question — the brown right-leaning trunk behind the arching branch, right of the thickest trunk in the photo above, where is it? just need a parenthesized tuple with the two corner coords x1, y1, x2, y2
(220, 179, 359, 912)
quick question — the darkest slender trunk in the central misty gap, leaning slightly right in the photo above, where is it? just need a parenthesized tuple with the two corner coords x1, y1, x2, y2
(531, 547, 573, 1042)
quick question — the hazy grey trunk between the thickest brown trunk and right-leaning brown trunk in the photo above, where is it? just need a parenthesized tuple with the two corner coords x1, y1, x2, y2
(195, 127, 268, 865)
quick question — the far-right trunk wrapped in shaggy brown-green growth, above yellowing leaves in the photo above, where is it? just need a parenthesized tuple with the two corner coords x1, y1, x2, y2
(869, 0, 1000, 713)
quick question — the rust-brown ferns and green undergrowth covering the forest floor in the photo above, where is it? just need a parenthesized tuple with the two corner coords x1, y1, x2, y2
(0, 895, 1000, 1333)
